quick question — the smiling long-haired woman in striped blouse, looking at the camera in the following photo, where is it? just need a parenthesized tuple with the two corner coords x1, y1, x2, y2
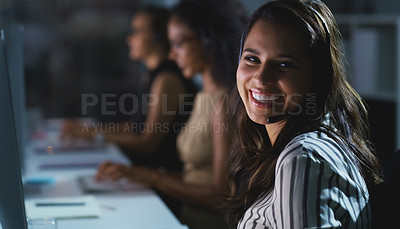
(227, 0, 381, 229)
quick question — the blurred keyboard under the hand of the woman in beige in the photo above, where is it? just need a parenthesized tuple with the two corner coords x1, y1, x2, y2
(78, 175, 148, 193)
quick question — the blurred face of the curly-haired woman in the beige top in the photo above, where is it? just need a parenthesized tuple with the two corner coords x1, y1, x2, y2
(168, 16, 207, 78)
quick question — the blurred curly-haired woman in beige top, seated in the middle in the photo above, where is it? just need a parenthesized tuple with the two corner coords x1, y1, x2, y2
(97, 0, 246, 229)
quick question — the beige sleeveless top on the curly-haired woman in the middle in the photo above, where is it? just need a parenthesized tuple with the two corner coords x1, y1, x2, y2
(177, 90, 226, 184)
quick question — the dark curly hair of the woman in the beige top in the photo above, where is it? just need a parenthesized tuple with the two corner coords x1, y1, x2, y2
(171, 0, 247, 88)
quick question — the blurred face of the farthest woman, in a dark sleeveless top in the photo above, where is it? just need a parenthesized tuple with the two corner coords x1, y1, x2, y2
(126, 13, 155, 60)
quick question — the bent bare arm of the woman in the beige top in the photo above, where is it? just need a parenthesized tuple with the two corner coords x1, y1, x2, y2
(96, 97, 229, 208)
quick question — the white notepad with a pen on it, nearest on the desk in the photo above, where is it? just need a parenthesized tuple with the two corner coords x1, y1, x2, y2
(25, 195, 101, 218)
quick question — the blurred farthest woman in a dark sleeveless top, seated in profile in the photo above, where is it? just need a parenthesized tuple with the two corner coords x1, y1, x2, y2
(62, 6, 195, 171)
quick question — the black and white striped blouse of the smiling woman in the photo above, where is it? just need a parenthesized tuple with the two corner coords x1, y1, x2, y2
(237, 132, 370, 229)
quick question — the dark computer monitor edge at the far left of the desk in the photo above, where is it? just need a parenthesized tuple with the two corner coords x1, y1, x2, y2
(0, 30, 27, 229)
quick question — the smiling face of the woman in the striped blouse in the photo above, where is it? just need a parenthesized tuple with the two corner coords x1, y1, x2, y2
(237, 20, 312, 124)
